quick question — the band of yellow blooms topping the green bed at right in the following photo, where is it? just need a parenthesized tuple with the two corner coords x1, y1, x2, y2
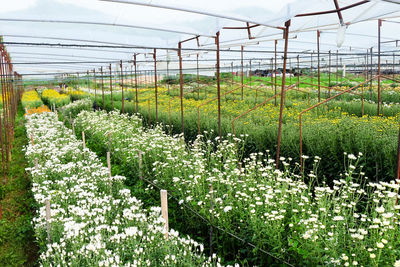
(132, 88, 399, 132)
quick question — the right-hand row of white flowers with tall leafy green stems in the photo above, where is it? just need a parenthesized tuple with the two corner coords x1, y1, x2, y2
(75, 111, 400, 266)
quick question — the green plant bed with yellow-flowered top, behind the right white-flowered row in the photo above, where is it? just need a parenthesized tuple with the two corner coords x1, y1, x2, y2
(84, 88, 399, 184)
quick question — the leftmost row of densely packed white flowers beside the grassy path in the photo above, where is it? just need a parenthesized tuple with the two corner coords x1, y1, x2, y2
(26, 112, 219, 266)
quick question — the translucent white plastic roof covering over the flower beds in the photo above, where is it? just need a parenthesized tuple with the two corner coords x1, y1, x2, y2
(0, 0, 400, 78)
